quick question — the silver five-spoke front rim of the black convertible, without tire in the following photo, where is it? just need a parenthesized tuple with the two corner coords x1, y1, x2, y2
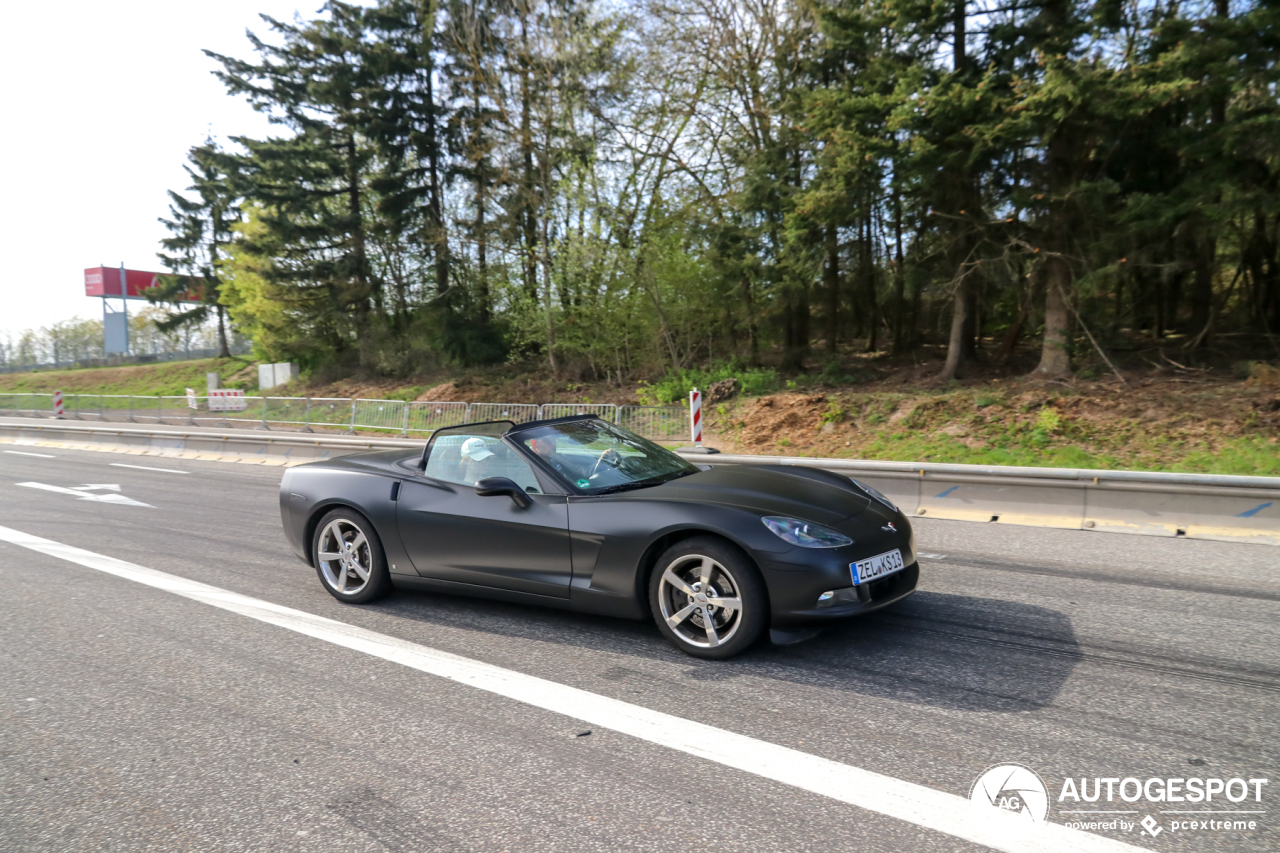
(658, 553, 742, 648)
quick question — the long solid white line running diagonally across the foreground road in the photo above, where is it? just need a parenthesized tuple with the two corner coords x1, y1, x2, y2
(0, 526, 1146, 853)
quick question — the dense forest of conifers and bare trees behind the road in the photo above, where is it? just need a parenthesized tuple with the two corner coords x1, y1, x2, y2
(2, 0, 1280, 394)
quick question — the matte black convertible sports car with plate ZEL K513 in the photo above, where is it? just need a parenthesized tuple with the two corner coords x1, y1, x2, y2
(280, 415, 919, 658)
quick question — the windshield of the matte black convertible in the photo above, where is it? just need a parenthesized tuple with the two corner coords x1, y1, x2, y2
(513, 418, 698, 494)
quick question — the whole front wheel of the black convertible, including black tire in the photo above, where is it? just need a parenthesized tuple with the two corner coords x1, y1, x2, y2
(649, 535, 769, 661)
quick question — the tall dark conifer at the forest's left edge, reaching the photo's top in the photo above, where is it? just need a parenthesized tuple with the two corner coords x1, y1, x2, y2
(206, 0, 385, 366)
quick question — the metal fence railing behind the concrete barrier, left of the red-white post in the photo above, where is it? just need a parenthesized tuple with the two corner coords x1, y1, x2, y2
(0, 393, 689, 441)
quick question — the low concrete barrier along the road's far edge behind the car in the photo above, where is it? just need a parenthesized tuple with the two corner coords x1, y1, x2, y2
(0, 419, 1280, 546)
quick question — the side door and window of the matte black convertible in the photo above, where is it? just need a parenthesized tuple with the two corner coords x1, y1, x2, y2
(396, 432, 572, 598)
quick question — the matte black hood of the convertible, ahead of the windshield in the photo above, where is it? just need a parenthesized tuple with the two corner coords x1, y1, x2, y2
(630, 465, 870, 525)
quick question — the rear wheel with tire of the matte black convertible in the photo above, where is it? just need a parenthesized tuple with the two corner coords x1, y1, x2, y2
(311, 507, 392, 605)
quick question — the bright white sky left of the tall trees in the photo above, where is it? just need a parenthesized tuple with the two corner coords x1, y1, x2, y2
(0, 0, 350, 333)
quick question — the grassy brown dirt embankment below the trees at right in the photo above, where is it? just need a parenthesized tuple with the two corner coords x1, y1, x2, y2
(707, 380, 1280, 475)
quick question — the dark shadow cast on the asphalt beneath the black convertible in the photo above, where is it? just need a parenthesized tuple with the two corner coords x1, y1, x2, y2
(372, 581, 1083, 713)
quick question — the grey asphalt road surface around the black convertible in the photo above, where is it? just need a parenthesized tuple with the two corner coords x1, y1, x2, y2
(0, 444, 1280, 853)
